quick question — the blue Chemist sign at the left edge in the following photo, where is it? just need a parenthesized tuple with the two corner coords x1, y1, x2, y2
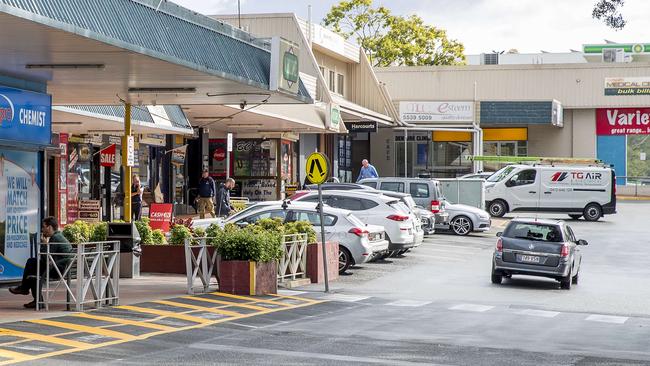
(0, 87, 52, 145)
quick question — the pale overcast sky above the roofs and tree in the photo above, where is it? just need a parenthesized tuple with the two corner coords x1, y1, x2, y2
(174, 0, 650, 54)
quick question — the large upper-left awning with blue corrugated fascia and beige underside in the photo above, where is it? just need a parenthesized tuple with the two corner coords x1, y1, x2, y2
(0, 0, 312, 105)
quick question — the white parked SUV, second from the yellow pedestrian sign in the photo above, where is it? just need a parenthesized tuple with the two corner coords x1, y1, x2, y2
(291, 190, 424, 252)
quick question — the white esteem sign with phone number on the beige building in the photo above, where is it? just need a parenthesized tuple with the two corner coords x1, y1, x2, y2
(399, 102, 474, 123)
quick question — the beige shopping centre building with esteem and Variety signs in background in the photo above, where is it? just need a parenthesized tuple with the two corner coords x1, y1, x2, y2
(371, 43, 650, 184)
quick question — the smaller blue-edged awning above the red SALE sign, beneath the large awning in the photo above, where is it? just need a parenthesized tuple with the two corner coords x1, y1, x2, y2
(52, 105, 194, 135)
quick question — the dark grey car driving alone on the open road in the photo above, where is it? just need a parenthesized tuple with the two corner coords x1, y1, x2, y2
(492, 219, 587, 290)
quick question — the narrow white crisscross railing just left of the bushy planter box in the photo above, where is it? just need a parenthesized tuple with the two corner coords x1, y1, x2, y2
(185, 237, 219, 295)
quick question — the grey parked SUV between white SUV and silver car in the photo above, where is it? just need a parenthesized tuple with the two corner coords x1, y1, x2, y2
(359, 177, 449, 229)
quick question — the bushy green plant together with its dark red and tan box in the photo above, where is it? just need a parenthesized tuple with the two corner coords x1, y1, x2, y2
(213, 223, 284, 295)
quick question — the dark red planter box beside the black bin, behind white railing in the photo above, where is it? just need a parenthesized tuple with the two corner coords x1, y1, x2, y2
(140, 245, 214, 274)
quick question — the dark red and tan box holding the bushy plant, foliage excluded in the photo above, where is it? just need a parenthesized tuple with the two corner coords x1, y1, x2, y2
(219, 260, 278, 295)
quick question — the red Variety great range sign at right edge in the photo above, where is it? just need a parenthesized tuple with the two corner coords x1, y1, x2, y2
(596, 108, 650, 136)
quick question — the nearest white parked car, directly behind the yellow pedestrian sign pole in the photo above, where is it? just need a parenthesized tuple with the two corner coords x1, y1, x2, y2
(224, 201, 388, 273)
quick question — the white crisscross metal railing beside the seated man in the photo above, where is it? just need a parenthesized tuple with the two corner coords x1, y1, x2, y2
(36, 241, 120, 311)
